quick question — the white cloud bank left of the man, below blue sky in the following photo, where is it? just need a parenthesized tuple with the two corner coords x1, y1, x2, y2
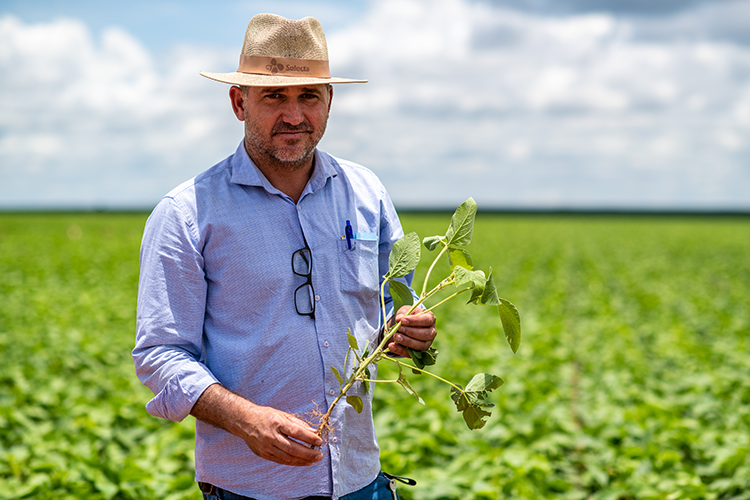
(0, 16, 241, 206)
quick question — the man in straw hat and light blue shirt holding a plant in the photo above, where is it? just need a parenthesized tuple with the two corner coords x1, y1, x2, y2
(133, 14, 436, 500)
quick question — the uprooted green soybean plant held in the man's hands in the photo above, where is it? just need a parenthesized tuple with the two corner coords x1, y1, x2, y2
(318, 198, 521, 435)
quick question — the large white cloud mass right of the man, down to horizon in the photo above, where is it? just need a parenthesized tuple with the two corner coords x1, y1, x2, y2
(329, 0, 750, 208)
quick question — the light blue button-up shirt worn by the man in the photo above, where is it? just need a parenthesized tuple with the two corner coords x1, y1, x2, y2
(133, 143, 411, 500)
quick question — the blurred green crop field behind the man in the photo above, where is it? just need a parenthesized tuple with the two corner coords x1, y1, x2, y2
(0, 213, 750, 500)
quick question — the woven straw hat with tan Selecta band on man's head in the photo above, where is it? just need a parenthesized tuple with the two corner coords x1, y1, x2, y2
(201, 14, 367, 87)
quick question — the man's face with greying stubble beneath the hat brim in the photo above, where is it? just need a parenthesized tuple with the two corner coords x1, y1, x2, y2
(230, 85, 332, 170)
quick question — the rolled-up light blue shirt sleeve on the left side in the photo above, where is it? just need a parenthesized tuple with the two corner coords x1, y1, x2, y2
(133, 197, 217, 421)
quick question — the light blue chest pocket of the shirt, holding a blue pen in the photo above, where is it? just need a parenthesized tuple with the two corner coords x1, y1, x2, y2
(338, 236, 380, 300)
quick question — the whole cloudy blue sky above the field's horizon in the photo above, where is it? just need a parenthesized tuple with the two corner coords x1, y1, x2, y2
(0, 0, 750, 211)
